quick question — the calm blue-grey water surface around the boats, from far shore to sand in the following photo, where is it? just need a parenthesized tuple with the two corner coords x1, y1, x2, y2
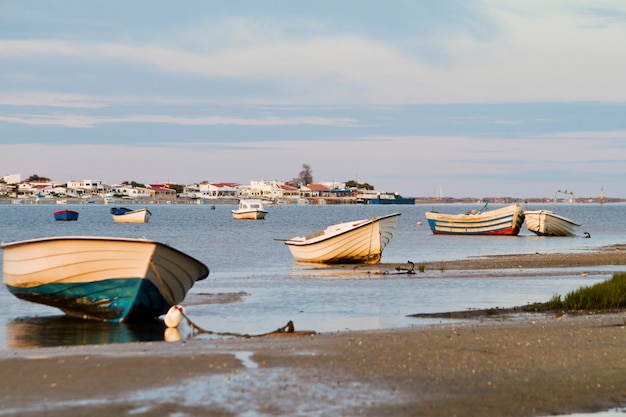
(0, 203, 626, 350)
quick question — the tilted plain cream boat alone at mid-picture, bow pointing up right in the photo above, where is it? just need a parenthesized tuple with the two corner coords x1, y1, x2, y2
(285, 213, 400, 264)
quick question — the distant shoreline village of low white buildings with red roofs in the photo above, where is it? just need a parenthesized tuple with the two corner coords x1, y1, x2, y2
(0, 174, 626, 205)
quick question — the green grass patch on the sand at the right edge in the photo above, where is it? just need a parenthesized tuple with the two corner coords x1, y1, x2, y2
(522, 272, 626, 311)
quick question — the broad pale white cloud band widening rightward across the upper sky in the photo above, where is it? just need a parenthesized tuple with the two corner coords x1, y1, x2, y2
(0, 1, 626, 104)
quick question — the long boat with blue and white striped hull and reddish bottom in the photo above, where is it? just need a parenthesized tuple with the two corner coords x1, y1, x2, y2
(426, 203, 524, 236)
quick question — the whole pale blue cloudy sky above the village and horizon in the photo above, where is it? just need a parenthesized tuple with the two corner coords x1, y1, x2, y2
(0, 0, 626, 198)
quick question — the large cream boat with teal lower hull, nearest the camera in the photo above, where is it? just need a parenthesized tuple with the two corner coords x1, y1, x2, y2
(0, 236, 209, 322)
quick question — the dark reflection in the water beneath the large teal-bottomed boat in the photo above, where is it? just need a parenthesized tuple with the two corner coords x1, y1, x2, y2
(4, 315, 165, 349)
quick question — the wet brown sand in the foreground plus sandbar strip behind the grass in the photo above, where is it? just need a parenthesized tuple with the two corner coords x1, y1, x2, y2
(0, 247, 626, 416)
